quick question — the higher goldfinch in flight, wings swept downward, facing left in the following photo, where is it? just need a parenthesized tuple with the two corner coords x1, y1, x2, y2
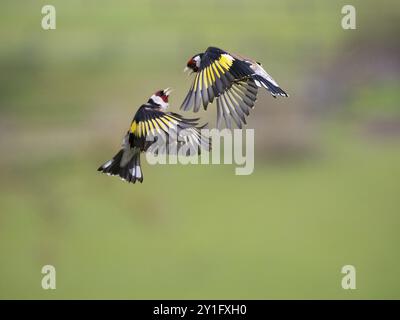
(181, 47, 288, 128)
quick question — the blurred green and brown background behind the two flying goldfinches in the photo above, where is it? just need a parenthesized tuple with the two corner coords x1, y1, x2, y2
(0, 0, 400, 299)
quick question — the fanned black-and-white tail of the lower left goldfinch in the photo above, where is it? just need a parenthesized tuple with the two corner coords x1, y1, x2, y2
(97, 149, 143, 183)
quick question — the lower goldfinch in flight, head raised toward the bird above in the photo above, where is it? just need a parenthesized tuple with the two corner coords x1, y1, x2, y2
(97, 88, 210, 183)
